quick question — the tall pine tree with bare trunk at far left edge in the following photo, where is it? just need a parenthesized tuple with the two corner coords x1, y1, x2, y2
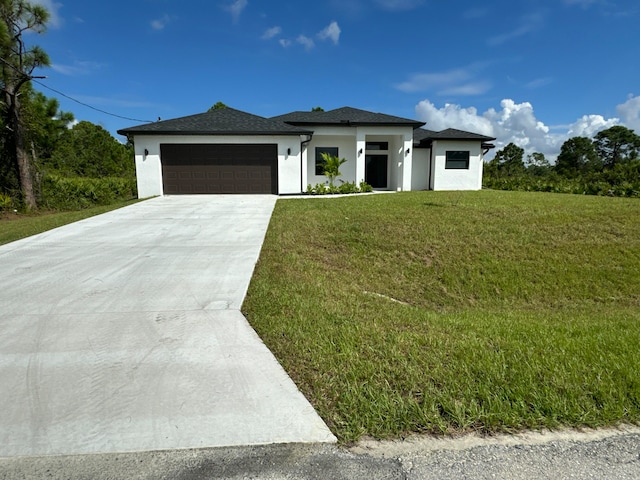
(0, 0, 49, 209)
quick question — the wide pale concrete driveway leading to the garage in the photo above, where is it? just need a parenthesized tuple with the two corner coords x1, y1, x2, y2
(0, 195, 335, 456)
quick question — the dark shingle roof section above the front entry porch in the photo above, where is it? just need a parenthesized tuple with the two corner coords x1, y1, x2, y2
(272, 107, 424, 128)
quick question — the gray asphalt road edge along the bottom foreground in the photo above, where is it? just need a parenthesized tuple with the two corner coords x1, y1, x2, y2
(0, 427, 640, 480)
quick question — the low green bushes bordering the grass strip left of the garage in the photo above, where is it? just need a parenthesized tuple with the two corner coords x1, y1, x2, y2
(40, 175, 137, 210)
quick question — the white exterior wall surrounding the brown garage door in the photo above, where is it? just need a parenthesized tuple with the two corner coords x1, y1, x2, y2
(134, 135, 306, 198)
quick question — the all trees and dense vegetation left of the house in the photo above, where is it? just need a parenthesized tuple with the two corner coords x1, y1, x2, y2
(0, 0, 136, 212)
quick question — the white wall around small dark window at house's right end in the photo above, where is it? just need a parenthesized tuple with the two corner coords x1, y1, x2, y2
(432, 140, 483, 190)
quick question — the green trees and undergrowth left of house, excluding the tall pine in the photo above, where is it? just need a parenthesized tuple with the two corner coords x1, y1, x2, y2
(0, 84, 136, 210)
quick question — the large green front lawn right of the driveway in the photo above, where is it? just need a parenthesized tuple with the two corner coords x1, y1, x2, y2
(243, 191, 640, 442)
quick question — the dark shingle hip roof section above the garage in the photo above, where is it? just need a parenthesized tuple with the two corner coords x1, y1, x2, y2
(118, 108, 312, 135)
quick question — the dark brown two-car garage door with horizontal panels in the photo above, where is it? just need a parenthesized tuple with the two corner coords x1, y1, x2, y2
(160, 144, 278, 195)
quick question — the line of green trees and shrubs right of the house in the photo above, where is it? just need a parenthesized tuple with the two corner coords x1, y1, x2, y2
(482, 125, 640, 197)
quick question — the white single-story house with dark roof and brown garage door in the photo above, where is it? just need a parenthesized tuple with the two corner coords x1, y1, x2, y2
(118, 107, 495, 198)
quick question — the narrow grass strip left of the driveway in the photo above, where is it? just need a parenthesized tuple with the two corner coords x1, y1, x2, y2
(0, 200, 138, 245)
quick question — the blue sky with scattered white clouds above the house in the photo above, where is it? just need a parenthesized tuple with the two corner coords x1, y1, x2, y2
(28, 0, 640, 160)
